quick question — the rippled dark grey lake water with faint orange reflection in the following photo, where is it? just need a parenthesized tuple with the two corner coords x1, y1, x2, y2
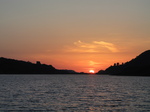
(0, 74, 150, 112)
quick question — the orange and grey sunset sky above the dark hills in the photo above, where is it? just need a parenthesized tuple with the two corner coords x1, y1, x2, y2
(0, 0, 150, 72)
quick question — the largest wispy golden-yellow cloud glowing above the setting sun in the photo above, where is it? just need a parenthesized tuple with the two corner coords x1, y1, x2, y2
(65, 40, 119, 53)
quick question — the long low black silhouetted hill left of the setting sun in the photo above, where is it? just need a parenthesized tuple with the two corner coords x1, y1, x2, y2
(0, 57, 76, 74)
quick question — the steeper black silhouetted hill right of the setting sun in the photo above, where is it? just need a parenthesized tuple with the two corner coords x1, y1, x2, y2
(97, 50, 150, 76)
